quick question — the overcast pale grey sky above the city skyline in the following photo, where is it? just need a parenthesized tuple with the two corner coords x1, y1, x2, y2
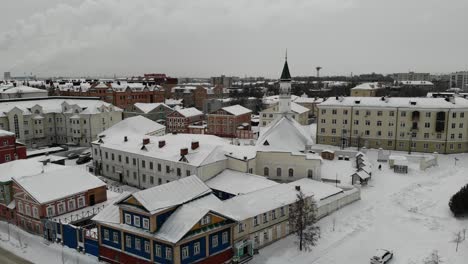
(0, 0, 468, 78)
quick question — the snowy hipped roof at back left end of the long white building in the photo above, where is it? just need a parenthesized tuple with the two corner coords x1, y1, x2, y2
(99, 115, 165, 140)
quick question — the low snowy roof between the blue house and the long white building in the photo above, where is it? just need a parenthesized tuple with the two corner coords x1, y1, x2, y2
(206, 169, 278, 195)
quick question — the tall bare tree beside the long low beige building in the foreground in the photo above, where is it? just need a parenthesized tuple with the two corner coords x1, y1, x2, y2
(289, 187, 320, 251)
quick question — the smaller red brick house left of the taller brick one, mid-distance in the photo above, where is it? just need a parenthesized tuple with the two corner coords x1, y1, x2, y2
(166, 107, 204, 133)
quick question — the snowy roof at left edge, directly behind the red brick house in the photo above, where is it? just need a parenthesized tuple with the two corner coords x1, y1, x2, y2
(0, 159, 64, 182)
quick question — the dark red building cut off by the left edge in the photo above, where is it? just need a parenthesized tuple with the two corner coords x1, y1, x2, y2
(0, 129, 26, 164)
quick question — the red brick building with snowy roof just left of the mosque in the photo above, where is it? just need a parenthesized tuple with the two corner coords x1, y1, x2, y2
(207, 105, 252, 138)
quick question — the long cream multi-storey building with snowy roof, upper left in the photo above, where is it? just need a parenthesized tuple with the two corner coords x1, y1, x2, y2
(0, 97, 122, 147)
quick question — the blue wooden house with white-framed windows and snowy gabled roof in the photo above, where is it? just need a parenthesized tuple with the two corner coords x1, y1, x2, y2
(93, 176, 235, 264)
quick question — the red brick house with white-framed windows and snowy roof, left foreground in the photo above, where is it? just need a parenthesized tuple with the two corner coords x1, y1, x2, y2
(12, 167, 107, 235)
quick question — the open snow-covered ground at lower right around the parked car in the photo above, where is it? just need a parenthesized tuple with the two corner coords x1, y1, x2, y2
(253, 150, 468, 264)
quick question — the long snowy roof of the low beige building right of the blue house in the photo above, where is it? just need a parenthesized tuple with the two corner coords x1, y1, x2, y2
(221, 178, 343, 220)
